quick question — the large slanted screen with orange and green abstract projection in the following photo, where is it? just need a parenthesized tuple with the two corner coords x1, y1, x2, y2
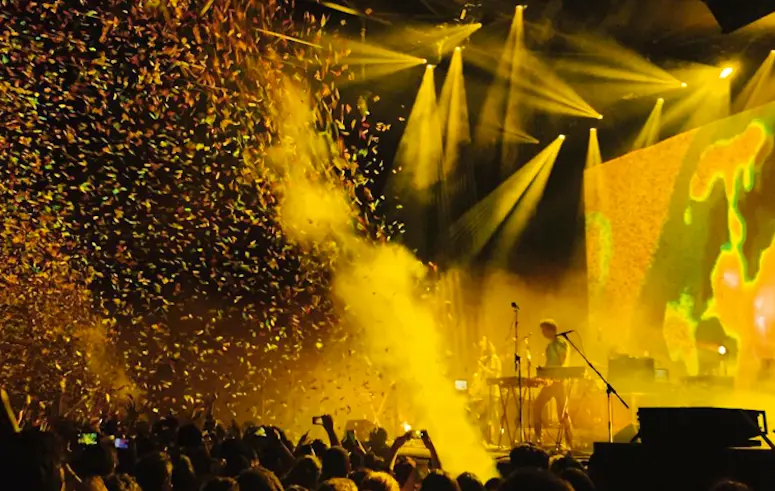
(584, 100, 775, 383)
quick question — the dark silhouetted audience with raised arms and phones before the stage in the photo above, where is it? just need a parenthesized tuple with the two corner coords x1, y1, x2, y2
(0, 390, 748, 491)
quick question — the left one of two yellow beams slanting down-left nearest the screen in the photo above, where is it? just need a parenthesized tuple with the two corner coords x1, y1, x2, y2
(448, 136, 564, 262)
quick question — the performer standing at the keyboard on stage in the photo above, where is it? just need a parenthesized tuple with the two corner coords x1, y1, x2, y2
(533, 320, 572, 446)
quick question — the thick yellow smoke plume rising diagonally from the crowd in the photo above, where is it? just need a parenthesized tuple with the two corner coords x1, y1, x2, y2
(271, 81, 495, 478)
